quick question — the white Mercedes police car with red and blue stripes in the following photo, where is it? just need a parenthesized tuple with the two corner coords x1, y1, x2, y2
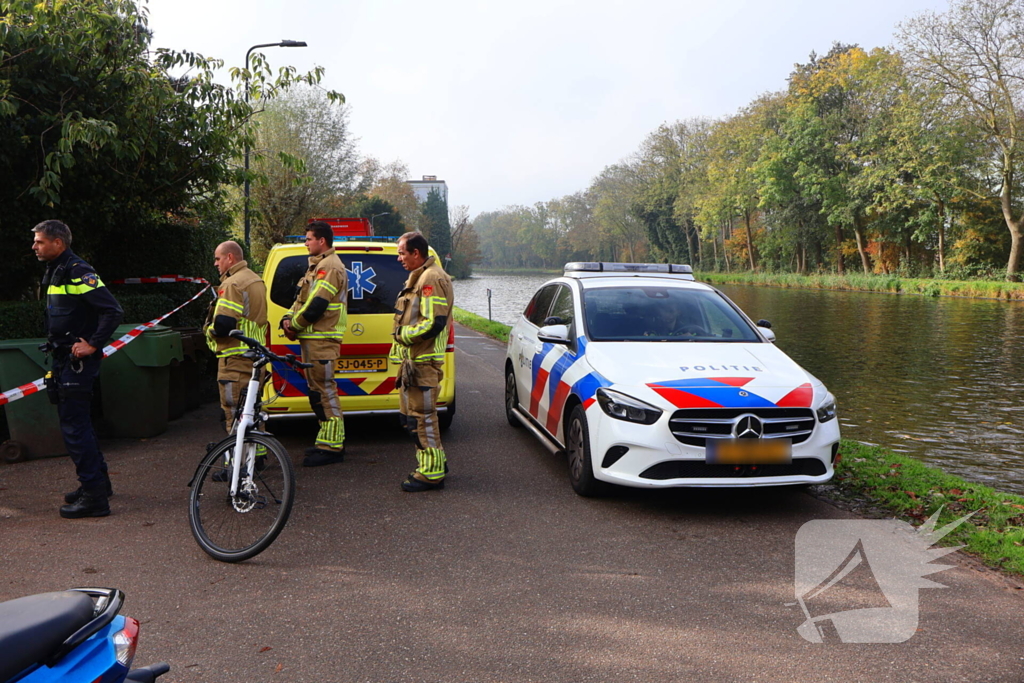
(505, 263, 840, 496)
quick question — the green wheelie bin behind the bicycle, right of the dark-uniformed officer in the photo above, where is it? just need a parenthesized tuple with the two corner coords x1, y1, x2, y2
(96, 325, 182, 438)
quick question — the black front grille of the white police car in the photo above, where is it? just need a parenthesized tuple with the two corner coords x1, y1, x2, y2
(669, 408, 814, 447)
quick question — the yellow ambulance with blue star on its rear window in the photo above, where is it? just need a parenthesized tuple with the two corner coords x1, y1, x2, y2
(263, 224, 456, 429)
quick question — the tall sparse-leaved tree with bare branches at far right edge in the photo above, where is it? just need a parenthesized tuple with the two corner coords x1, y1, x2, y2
(899, 0, 1024, 281)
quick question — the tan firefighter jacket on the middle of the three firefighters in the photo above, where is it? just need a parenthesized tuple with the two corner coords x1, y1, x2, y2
(284, 249, 348, 344)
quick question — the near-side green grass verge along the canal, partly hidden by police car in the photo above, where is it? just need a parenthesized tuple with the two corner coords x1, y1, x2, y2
(455, 307, 1024, 577)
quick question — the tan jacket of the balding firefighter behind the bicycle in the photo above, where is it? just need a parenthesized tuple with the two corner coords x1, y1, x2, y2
(206, 261, 266, 358)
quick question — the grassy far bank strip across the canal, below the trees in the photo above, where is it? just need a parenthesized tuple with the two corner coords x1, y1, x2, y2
(694, 272, 1024, 301)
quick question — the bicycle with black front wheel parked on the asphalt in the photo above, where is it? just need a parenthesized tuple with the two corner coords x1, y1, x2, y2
(188, 330, 312, 562)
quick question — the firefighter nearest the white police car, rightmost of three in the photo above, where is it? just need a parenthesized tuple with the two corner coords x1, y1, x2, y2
(389, 232, 455, 493)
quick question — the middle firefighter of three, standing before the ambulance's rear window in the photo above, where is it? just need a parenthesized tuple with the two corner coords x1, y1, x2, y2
(281, 220, 348, 467)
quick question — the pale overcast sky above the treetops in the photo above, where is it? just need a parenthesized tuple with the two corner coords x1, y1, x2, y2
(148, 0, 947, 215)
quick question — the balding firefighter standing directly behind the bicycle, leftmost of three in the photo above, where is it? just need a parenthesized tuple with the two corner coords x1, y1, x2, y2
(206, 237, 266, 436)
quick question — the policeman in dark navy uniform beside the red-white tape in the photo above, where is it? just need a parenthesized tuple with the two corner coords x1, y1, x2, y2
(32, 220, 124, 519)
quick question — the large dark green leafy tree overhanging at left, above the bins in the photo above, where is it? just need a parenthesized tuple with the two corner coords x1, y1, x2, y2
(0, 0, 341, 298)
